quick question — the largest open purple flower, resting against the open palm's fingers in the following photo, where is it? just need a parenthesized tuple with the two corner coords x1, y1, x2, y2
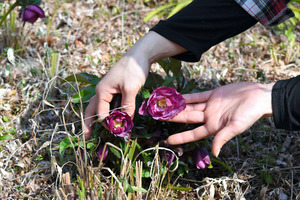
(139, 86, 186, 120)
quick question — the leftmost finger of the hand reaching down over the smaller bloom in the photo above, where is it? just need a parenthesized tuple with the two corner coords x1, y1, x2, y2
(83, 96, 97, 140)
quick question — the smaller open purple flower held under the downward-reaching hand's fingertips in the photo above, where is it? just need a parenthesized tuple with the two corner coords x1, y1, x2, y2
(104, 110, 133, 137)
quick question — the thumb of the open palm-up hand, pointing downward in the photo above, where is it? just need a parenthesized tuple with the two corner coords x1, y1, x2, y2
(212, 124, 239, 157)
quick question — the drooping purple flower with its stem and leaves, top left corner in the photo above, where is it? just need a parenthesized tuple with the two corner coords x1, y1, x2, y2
(0, 0, 45, 27)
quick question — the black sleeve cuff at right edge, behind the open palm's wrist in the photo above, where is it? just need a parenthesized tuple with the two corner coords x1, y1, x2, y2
(272, 76, 300, 130)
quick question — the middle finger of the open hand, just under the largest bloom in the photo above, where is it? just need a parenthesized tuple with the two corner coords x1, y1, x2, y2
(167, 110, 204, 124)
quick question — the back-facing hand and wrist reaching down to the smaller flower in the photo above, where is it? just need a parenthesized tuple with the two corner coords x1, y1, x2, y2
(84, 31, 186, 139)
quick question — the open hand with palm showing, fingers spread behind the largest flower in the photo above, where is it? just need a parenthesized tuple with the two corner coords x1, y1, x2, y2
(167, 82, 274, 157)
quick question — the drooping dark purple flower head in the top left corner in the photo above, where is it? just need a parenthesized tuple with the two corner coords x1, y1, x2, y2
(21, 5, 45, 24)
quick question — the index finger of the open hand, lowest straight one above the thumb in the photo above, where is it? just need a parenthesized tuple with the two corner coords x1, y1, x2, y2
(167, 125, 212, 145)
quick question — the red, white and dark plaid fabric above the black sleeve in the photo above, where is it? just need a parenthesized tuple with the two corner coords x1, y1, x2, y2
(235, 0, 294, 26)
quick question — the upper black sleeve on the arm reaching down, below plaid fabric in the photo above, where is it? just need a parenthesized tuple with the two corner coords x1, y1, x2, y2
(151, 0, 257, 62)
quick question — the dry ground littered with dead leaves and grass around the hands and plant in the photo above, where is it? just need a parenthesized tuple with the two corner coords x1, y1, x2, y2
(0, 0, 300, 199)
